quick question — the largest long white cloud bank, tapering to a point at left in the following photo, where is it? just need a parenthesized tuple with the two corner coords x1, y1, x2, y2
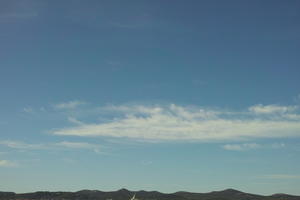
(52, 104, 300, 141)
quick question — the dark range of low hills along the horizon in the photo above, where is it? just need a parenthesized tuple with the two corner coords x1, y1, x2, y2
(0, 189, 300, 200)
